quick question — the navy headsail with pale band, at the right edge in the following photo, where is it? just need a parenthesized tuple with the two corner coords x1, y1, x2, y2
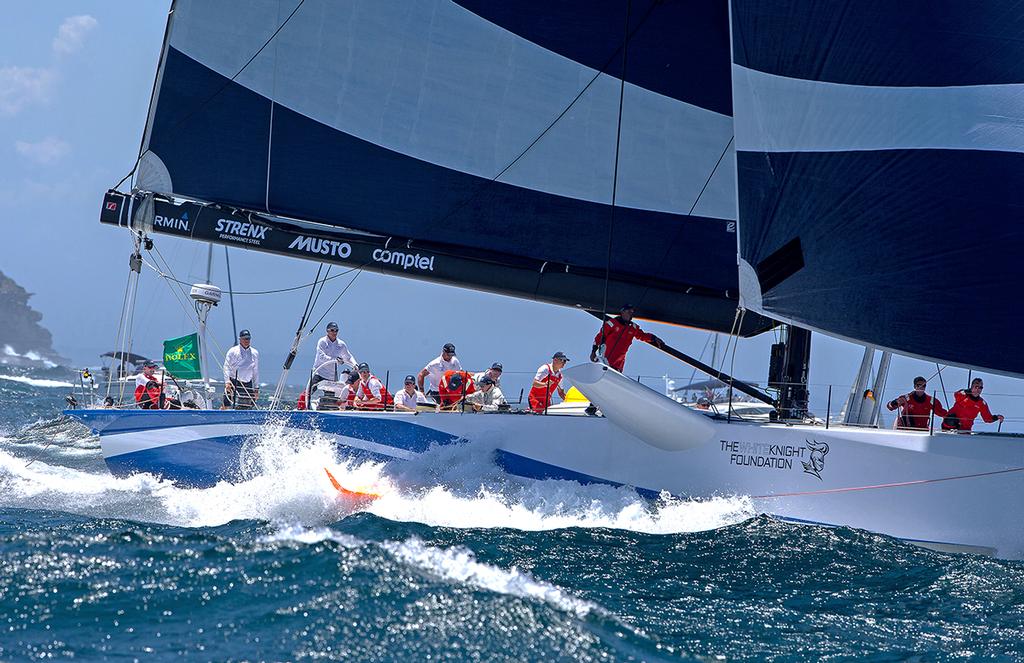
(731, 0, 1024, 375)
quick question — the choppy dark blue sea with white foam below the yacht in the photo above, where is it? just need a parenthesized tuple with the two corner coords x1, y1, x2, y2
(0, 369, 1024, 661)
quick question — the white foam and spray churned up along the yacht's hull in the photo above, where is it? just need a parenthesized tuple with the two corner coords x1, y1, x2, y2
(0, 426, 756, 534)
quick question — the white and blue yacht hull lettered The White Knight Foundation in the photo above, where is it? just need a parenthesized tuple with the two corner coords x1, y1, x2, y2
(73, 365, 1024, 558)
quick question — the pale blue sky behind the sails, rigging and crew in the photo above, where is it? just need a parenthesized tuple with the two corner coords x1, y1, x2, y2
(0, 0, 1024, 426)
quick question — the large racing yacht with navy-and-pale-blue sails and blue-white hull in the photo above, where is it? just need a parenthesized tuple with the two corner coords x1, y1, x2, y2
(71, 0, 1024, 558)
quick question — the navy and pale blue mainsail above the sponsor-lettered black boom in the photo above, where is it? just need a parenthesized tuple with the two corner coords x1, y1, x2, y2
(121, 0, 773, 334)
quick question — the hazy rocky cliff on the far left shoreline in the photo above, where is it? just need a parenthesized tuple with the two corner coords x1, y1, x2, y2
(0, 272, 63, 366)
